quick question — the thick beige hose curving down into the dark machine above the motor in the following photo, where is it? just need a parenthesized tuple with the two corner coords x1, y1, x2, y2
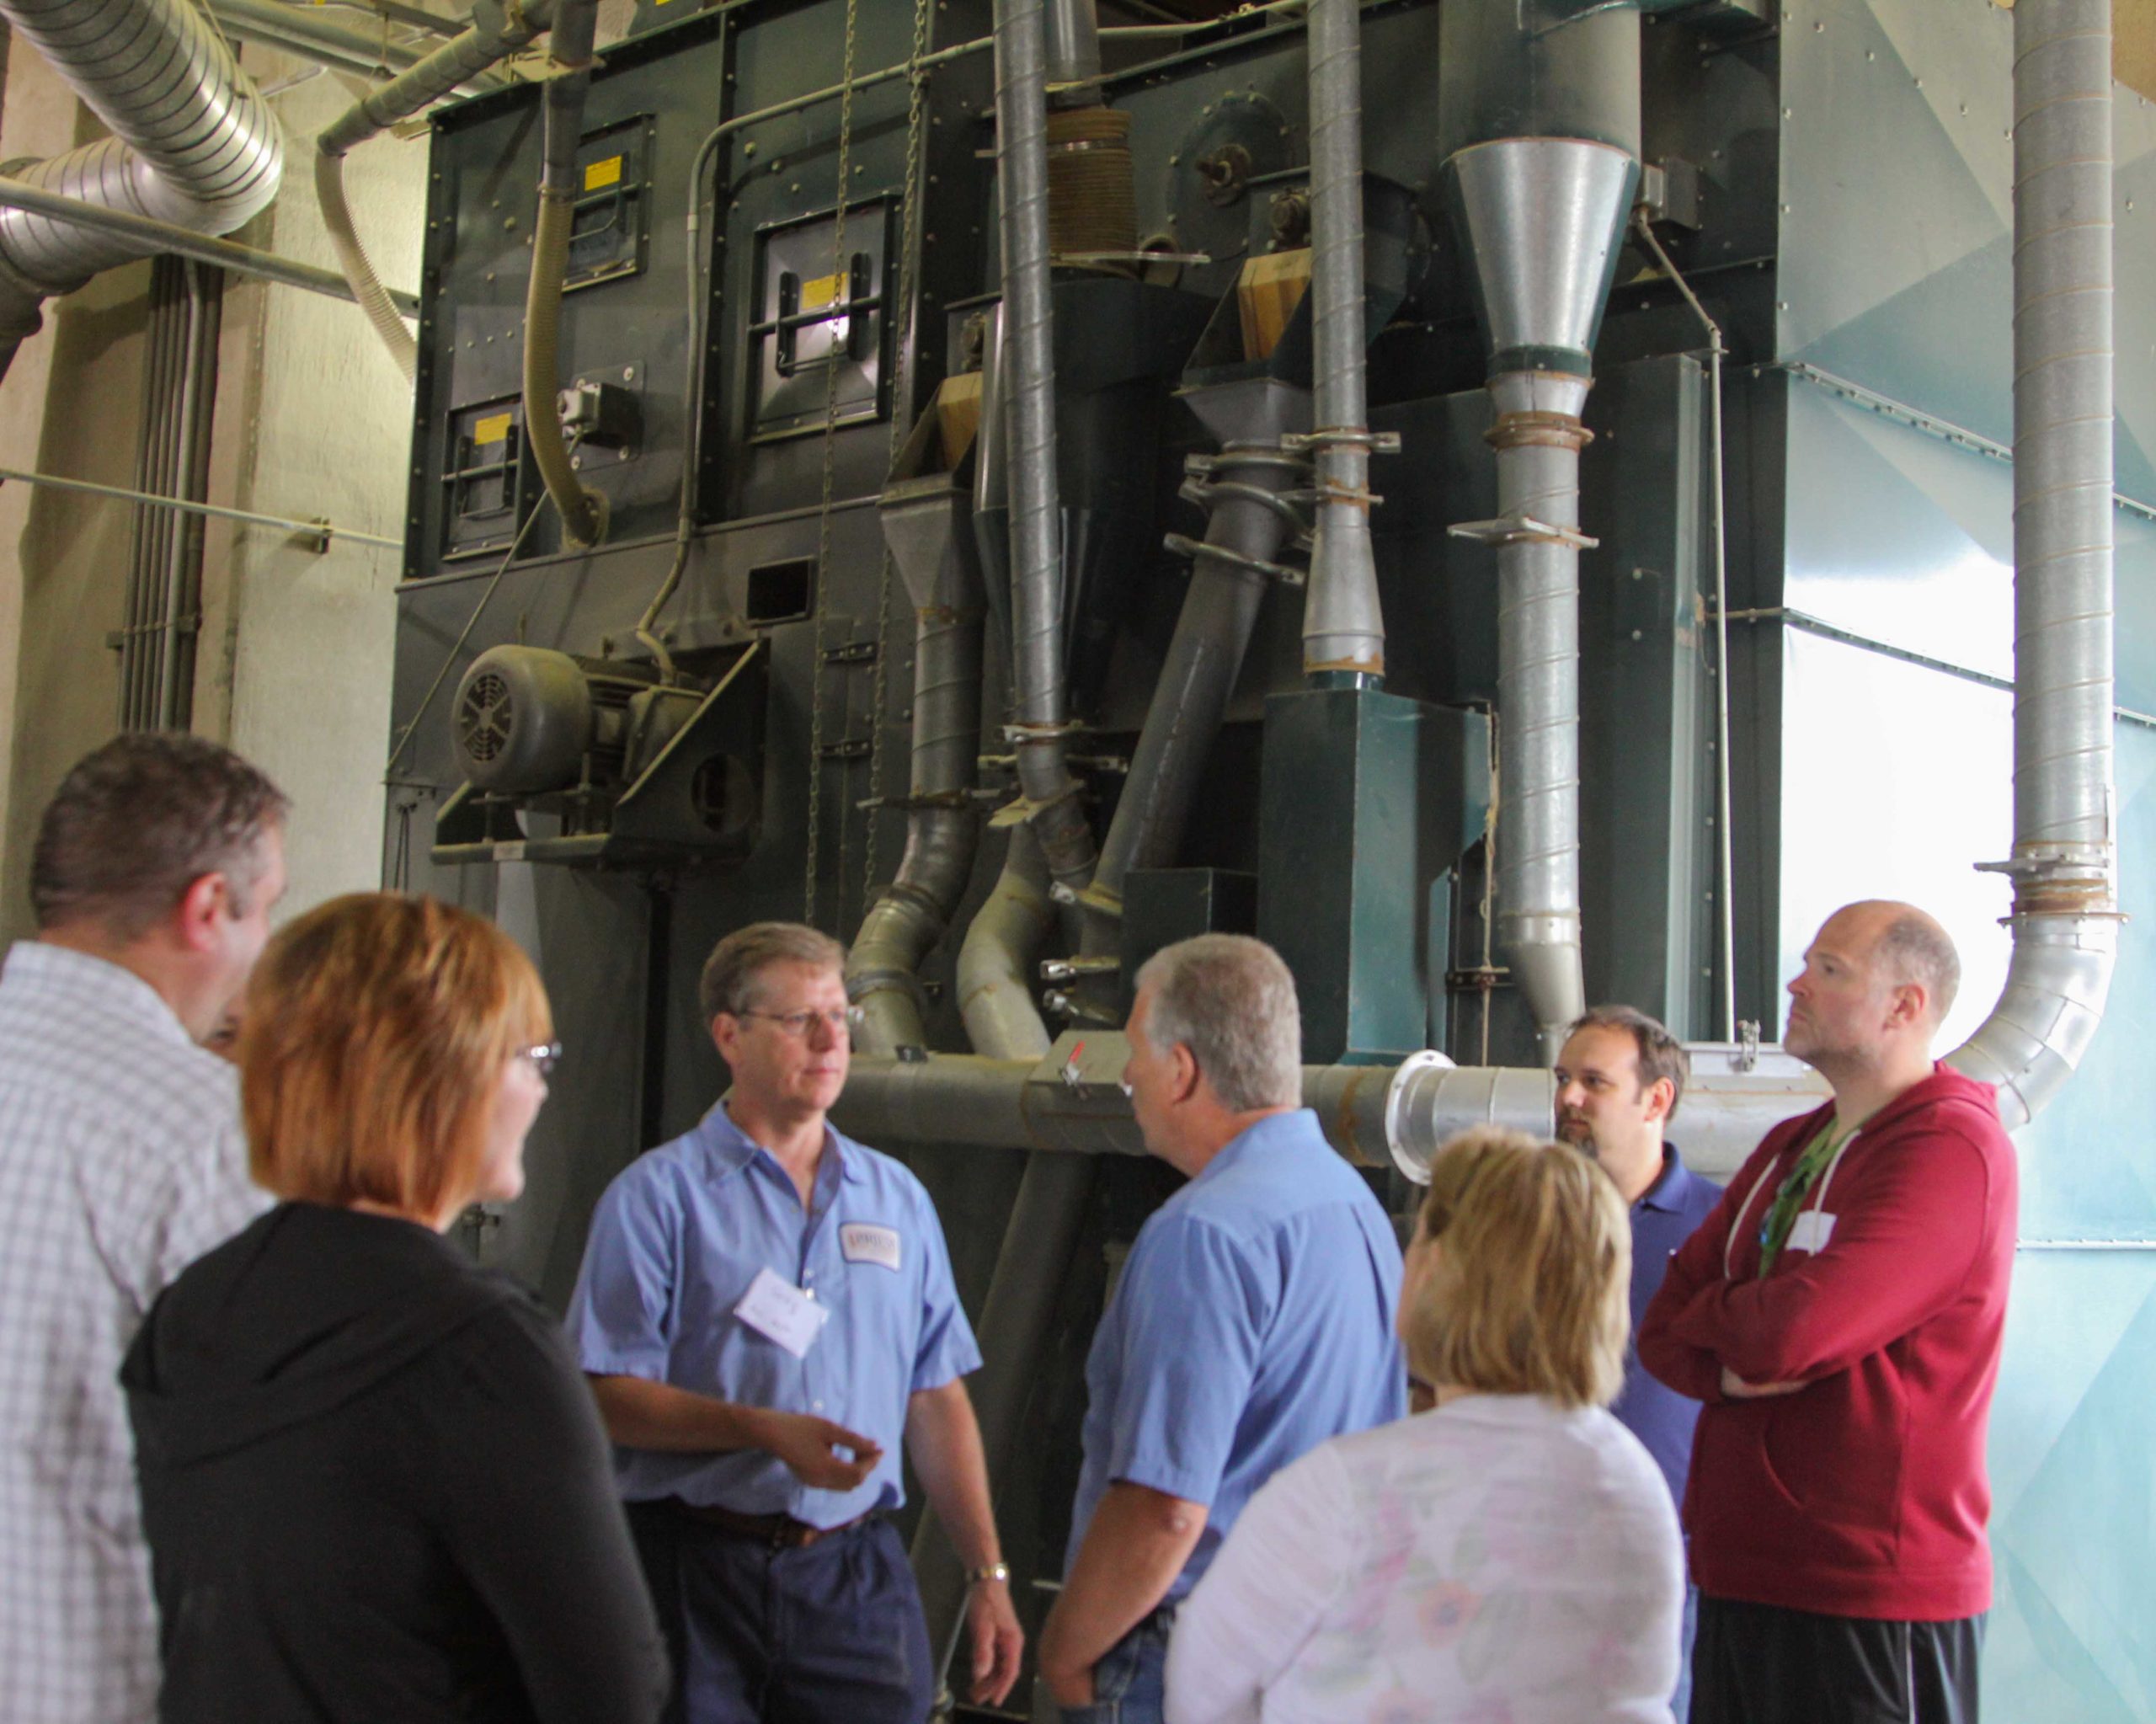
(524, 0, 608, 547)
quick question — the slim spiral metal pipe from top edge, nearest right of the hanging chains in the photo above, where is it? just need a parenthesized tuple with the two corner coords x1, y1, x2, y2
(996, 0, 1093, 892)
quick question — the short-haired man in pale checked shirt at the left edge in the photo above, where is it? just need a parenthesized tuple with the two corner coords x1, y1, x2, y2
(0, 735, 286, 1724)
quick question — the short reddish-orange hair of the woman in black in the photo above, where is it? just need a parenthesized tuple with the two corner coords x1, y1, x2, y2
(239, 892, 554, 1215)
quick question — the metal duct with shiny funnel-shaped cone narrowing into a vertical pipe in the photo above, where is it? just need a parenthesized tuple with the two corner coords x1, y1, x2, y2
(1440, 7, 1639, 1060)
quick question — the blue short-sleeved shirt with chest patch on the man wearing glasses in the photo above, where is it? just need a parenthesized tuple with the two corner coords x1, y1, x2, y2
(567, 1103, 981, 1526)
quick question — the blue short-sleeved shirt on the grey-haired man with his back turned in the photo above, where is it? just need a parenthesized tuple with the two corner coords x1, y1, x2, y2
(1065, 1108, 1408, 1604)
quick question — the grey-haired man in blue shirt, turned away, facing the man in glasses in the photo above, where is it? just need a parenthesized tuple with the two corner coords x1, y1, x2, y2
(1039, 933, 1406, 1724)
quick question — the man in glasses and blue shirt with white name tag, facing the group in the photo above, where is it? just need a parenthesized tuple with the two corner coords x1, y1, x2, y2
(569, 922, 1024, 1724)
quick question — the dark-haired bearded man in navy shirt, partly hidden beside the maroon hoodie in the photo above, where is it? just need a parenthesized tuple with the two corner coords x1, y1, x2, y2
(1555, 1006, 1722, 1720)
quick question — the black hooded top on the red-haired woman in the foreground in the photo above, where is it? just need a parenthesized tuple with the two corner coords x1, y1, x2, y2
(120, 1204, 666, 1724)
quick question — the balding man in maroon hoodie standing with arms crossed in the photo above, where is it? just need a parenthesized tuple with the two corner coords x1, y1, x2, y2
(1639, 903, 2016, 1724)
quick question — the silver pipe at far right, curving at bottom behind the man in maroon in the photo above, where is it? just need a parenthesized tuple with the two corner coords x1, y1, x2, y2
(1949, 0, 2119, 1129)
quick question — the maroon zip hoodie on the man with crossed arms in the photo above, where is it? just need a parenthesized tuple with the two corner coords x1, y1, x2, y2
(1639, 1065, 2016, 1623)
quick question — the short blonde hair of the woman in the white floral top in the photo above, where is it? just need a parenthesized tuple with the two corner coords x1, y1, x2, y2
(1401, 1127, 1632, 1407)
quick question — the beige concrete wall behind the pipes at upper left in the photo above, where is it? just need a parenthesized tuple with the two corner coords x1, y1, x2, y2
(0, 43, 427, 937)
